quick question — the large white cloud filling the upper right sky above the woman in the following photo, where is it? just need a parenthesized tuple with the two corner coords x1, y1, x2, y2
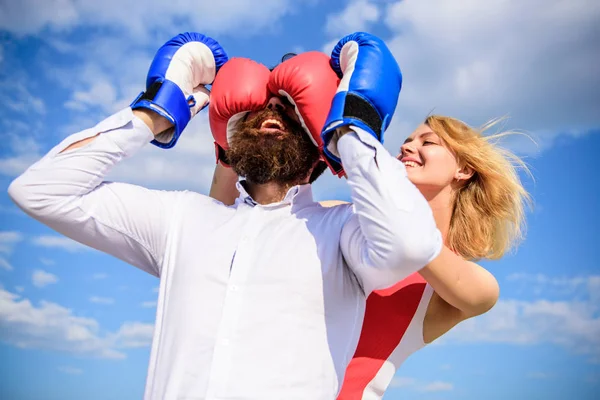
(327, 0, 600, 153)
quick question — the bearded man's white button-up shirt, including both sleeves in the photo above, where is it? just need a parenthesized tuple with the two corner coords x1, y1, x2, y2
(9, 108, 442, 400)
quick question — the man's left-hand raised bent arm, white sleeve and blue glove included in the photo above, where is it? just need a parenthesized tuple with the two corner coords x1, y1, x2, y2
(8, 33, 227, 276)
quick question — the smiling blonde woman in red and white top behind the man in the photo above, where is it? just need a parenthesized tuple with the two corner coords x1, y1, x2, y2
(211, 115, 529, 400)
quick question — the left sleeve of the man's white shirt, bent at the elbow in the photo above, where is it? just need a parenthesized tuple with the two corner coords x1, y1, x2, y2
(8, 108, 183, 276)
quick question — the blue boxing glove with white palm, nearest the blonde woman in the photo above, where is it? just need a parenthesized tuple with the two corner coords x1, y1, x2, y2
(321, 32, 402, 163)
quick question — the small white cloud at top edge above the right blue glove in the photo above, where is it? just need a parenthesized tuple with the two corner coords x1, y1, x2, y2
(325, 0, 380, 36)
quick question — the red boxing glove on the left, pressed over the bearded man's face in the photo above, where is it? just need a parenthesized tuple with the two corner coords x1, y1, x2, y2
(208, 58, 271, 165)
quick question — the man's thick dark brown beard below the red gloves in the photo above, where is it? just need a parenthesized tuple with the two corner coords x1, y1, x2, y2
(227, 109, 320, 185)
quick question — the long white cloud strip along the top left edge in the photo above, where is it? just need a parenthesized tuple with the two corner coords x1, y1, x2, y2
(0, 0, 293, 38)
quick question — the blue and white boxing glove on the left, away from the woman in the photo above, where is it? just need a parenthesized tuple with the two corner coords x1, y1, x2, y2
(131, 32, 227, 149)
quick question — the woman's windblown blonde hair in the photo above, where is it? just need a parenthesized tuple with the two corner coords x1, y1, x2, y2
(425, 115, 531, 260)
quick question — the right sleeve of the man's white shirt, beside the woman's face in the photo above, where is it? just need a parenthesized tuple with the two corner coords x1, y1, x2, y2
(337, 127, 443, 295)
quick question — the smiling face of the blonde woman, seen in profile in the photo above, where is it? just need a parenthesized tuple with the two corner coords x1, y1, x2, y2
(398, 124, 462, 192)
